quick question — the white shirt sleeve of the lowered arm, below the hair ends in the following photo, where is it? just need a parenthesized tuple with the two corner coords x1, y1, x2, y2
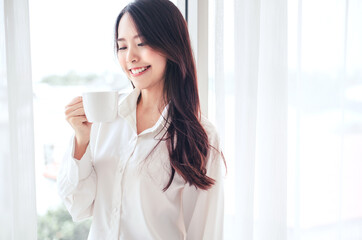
(183, 133, 225, 240)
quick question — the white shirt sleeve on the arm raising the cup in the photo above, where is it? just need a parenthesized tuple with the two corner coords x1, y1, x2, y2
(57, 126, 97, 221)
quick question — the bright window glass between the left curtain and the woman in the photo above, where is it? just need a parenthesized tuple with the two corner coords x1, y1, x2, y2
(29, 0, 188, 240)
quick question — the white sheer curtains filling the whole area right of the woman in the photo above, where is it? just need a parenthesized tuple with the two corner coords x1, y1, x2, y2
(209, 0, 362, 240)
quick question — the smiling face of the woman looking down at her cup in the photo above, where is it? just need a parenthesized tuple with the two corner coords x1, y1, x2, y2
(118, 13, 167, 90)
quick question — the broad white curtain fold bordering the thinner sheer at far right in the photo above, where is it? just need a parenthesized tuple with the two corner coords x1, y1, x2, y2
(254, 0, 288, 240)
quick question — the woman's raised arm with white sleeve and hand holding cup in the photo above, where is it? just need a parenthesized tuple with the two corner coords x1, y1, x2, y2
(57, 97, 98, 221)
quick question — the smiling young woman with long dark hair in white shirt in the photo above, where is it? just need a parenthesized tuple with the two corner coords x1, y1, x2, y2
(58, 0, 224, 240)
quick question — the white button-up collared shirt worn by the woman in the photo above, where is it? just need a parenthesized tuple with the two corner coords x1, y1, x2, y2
(57, 89, 224, 240)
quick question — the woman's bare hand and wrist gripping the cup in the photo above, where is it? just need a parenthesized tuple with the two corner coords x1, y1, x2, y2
(65, 97, 92, 160)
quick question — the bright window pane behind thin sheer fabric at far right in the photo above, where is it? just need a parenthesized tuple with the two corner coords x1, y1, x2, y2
(288, 0, 362, 240)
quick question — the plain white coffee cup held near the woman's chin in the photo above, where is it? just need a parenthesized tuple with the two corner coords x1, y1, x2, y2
(82, 91, 118, 122)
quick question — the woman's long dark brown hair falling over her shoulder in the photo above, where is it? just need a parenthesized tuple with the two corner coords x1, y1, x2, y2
(114, 0, 215, 191)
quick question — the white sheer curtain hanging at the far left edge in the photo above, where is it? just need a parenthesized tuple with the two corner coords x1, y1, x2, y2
(0, 0, 36, 240)
